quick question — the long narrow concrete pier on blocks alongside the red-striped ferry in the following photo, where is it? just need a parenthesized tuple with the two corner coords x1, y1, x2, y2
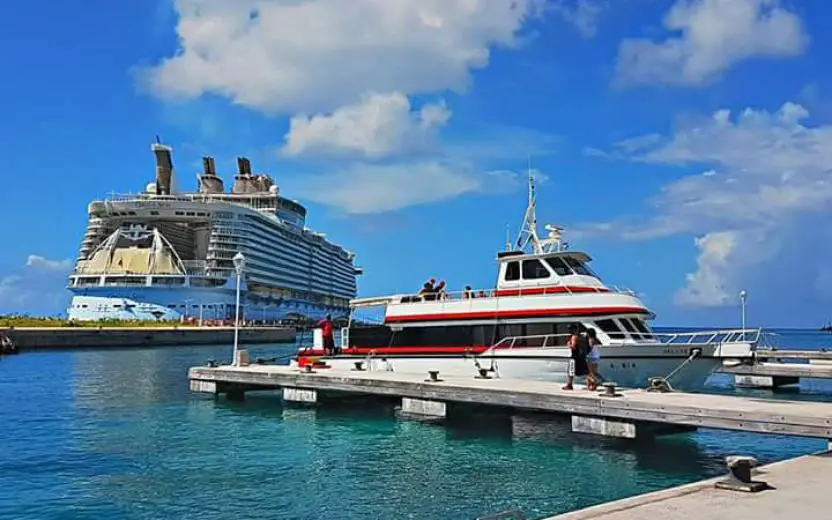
(189, 365, 832, 439)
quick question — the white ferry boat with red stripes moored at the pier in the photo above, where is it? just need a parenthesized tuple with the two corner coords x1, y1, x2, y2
(293, 175, 760, 391)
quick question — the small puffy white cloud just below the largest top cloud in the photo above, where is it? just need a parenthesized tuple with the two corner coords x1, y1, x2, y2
(282, 92, 451, 157)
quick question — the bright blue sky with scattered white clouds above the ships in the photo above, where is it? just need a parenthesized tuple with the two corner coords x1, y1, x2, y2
(0, 0, 832, 327)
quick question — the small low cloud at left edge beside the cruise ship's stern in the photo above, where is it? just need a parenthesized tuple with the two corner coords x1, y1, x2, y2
(0, 255, 72, 315)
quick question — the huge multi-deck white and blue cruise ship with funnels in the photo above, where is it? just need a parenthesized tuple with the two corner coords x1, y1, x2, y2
(68, 138, 361, 322)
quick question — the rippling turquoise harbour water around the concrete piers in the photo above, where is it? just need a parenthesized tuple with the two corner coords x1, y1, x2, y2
(0, 331, 832, 520)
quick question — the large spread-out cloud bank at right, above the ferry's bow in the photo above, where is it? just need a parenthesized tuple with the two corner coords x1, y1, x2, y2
(580, 102, 832, 305)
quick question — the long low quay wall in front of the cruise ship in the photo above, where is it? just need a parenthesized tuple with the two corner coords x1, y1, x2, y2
(0, 326, 295, 351)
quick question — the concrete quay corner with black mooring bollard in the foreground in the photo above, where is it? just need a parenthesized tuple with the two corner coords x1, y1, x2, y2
(547, 453, 832, 520)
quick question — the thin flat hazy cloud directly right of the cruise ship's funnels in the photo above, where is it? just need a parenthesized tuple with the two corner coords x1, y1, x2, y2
(297, 160, 521, 215)
